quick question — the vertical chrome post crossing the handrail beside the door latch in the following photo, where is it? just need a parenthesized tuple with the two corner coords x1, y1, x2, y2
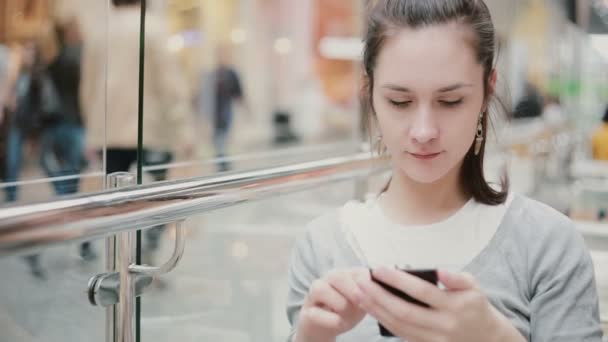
(106, 172, 135, 342)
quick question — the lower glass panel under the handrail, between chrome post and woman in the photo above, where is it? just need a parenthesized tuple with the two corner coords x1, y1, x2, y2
(142, 182, 364, 342)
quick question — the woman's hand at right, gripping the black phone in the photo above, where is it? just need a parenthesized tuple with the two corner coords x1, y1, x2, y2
(357, 268, 525, 342)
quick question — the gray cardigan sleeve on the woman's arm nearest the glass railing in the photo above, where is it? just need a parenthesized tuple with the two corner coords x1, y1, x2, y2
(287, 229, 320, 341)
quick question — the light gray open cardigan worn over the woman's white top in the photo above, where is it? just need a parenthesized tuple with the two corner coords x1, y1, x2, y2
(287, 195, 602, 342)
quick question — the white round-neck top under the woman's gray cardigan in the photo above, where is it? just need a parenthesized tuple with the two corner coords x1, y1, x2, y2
(340, 195, 513, 271)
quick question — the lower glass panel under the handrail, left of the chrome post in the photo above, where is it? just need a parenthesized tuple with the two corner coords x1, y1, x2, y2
(0, 241, 105, 342)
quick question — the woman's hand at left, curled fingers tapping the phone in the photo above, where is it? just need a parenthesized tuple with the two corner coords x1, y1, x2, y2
(295, 269, 369, 342)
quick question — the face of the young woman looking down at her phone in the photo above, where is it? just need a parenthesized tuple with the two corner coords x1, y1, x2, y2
(372, 24, 484, 183)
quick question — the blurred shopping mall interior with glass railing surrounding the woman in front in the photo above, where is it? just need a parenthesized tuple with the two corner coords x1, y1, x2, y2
(0, 0, 608, 342)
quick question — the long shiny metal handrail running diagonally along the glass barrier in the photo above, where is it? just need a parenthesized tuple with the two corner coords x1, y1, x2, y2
(0, 152, 387, 256)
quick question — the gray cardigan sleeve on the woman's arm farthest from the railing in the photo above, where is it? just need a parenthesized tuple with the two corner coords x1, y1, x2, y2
(528, 218, 602, 342)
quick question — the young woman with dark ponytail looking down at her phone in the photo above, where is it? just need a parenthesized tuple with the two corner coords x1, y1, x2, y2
(287, 0, 602, 342)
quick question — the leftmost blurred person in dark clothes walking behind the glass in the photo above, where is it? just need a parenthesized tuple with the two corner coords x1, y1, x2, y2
(4, 42, 59, 278)
